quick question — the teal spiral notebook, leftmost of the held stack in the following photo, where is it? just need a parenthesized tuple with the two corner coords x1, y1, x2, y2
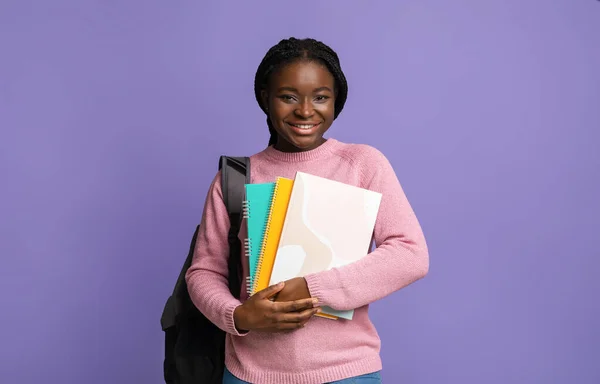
(243, 183, 275, 293)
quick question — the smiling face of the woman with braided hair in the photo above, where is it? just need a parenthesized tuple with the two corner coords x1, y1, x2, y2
(263, 61, 335, 152)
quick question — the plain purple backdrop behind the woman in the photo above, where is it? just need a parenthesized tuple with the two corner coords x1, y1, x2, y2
(0, 0, 600, 384)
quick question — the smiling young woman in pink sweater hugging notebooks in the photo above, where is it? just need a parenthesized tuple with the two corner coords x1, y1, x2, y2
(187, 38, 429, 384)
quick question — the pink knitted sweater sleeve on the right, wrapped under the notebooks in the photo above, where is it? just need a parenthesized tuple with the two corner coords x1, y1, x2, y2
(305, 148, 429, 310)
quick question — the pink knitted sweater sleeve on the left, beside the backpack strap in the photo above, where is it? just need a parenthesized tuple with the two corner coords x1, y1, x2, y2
(186, 172, 245, 336)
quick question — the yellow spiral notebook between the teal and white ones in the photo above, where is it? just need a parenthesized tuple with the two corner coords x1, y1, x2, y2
(251, 177, 337, 320)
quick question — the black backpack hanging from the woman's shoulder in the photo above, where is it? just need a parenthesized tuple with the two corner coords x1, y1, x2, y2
(160, 156, 250, 384)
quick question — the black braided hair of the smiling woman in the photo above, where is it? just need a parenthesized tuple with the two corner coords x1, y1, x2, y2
(254, 37, 348, 145)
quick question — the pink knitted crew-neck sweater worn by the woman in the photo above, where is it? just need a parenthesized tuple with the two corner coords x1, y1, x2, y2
(187, 139, 429, 384)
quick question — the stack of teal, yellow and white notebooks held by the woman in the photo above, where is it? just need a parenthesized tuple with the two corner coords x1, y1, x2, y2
(244, 172, 381, 320)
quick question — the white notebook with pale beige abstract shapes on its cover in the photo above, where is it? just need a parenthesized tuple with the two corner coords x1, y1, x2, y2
(269, 172, 382, 320)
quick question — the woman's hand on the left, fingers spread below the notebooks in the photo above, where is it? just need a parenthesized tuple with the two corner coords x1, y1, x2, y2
(233, 283, 320, 332)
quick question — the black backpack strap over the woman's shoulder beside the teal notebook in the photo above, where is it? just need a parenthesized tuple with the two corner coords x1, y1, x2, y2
(219, 156, 250, 299)
